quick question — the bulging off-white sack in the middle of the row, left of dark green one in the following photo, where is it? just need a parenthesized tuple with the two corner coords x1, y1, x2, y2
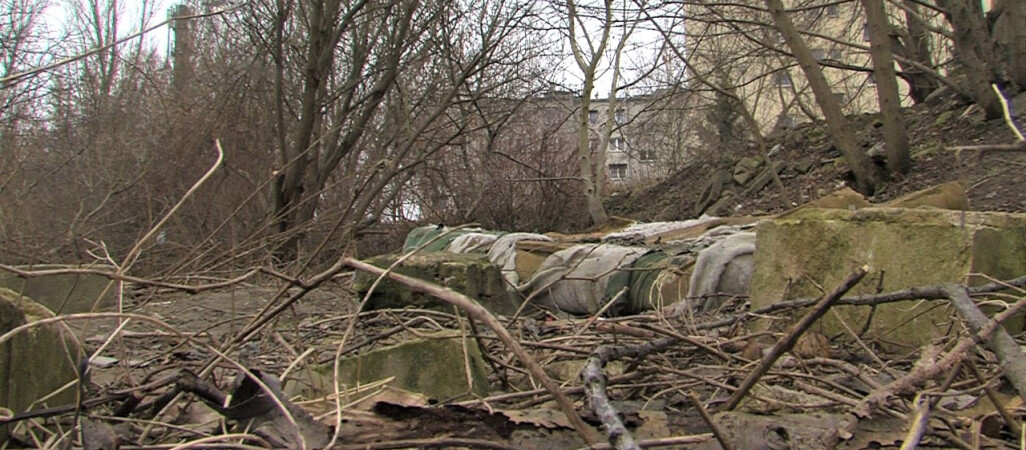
(519, 244, 648, 315)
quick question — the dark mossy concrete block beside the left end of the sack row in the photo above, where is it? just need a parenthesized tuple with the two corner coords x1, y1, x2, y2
(353, 251, 518, 315)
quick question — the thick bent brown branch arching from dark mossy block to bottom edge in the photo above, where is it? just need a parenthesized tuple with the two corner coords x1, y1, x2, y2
(341, 257, 597, 444)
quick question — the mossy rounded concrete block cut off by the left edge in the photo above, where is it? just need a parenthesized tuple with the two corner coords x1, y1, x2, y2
(0, 288, 81, 443)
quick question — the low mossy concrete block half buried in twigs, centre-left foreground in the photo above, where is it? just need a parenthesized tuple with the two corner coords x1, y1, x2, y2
(295, 333, 488, 401)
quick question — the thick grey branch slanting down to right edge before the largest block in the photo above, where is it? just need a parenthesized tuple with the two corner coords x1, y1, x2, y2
(943, 284, 1026, 399)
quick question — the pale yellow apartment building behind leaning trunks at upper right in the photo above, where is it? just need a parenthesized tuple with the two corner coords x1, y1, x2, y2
(684, 0, 944, 134)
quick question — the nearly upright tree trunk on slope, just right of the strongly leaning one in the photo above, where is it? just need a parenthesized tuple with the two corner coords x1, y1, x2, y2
(862, 0, 911, 175)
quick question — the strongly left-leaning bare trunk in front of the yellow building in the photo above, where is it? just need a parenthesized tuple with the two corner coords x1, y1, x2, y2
(765, 0, 880, 195)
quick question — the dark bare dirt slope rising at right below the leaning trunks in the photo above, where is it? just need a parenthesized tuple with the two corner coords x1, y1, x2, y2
(607, 90, 1026, 221)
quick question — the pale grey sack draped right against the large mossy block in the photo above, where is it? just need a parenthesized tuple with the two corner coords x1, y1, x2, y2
(687, 230, 755, 312)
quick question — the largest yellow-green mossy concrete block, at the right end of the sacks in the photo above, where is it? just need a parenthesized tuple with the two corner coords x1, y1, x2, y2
(751, 208, 1026, 352)
